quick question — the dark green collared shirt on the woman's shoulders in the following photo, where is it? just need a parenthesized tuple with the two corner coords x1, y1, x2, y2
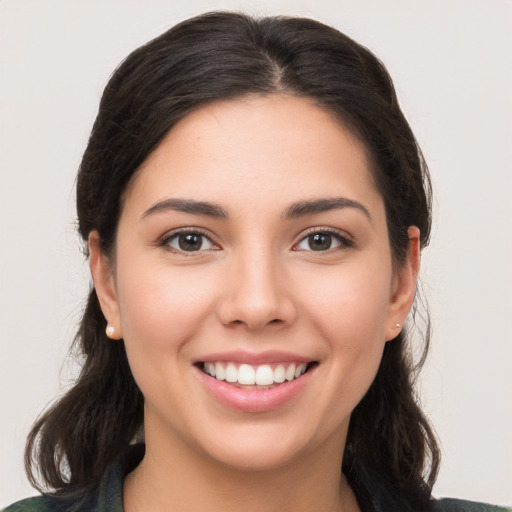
(3, 445, 512, 512)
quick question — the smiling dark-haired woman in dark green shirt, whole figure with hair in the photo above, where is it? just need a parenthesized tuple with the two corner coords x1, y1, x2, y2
(3, 13, 508, 512)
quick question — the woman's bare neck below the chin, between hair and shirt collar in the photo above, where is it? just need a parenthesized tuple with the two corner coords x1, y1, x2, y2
(123, 424, 359, 512)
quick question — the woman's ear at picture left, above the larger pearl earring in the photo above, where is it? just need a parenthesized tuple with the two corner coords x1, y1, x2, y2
(88, 230, 123, 340)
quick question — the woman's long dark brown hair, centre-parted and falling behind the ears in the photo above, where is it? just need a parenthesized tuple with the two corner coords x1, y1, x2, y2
(25, 12, 439, 508)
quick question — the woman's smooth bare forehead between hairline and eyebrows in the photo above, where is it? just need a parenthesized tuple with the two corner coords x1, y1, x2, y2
(125, 95, 380, 219)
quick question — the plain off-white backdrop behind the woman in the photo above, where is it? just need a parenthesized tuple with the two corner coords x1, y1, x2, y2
(0, 0, 512, 507)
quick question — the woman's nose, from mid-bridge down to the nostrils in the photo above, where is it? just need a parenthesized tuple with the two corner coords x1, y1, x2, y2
(218, 245, 297, 331)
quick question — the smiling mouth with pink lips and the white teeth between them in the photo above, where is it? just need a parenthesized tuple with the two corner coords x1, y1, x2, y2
(194, 352, 318, 412)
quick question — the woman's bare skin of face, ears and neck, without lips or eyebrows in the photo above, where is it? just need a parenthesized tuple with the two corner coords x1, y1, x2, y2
(89, 95, 419, 512)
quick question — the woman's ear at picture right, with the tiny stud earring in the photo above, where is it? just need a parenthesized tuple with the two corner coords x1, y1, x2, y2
(386, 226, 420, 341)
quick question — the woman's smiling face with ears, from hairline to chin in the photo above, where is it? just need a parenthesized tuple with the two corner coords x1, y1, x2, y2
(91, 96, 416, 469)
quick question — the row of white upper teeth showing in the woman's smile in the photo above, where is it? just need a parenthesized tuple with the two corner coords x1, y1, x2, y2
(204, 363, 307, 386)
